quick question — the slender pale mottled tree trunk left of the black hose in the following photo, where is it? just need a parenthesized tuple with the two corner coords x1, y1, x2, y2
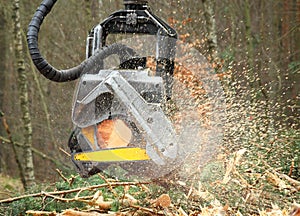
(14, 0, 35, 189)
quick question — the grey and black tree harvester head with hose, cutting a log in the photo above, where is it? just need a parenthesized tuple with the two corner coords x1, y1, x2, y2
(27, 0, 211, 178)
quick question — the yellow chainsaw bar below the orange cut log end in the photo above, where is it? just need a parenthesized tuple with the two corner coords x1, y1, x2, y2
(74, 148, 150, 162)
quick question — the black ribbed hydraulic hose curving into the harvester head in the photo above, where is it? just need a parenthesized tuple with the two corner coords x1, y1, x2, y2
(27, 0, 135, 82)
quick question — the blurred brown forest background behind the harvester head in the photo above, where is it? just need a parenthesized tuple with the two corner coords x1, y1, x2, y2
(0, 0, 300, 213)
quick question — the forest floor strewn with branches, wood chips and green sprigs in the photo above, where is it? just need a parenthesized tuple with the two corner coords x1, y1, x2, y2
(0, 150, 300, 216)
